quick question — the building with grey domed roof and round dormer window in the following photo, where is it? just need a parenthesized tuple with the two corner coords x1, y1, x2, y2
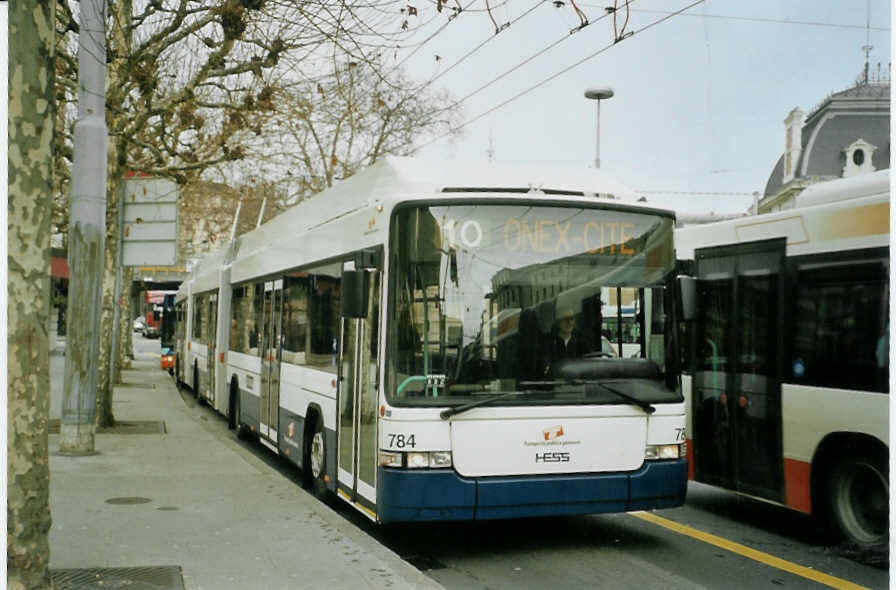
(759, 66, 890, 213)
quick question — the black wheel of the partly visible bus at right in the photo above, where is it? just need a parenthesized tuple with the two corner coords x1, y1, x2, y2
(828, 456, 890, 548)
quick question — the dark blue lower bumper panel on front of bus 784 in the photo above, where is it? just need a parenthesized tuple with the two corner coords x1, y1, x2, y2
(377, 459, 688, 522)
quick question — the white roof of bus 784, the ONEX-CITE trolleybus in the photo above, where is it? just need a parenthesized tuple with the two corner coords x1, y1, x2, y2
(192, 156, 673, 293)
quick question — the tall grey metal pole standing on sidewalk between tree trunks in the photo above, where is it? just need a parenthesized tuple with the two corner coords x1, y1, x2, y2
(59, 0, 108, 455)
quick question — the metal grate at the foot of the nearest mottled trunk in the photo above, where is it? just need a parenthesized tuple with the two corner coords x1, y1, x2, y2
(50, 565, 184, 590)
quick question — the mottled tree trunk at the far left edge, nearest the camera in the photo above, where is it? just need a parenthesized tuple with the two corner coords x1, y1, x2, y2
(6, 0, 55, 589)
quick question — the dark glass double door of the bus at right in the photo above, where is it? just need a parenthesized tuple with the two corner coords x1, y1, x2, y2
(693, 239, 785, 500)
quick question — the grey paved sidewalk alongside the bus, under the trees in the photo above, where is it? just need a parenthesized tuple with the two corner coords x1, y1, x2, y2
(50, 346, 441, 590)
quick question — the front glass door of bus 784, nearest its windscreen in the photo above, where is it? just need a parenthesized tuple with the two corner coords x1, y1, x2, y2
(338, 262, 380, 513)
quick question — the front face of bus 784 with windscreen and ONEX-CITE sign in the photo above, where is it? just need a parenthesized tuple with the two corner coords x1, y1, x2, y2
(376, 200, 687, 522)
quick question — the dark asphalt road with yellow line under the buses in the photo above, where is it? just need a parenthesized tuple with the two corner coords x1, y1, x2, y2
(134, 335, 889, 590)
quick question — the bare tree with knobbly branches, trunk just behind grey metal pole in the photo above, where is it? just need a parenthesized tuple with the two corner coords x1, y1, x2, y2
(57, 0, 432, 424)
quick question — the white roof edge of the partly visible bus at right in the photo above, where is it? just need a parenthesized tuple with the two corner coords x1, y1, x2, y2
(675, 170, 890, 260)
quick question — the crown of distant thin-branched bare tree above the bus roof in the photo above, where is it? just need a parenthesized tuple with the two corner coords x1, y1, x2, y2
(231, 58, 461, 204)
